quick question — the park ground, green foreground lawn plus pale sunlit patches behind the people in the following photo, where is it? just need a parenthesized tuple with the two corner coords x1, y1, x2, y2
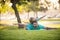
(0, 15, 60, 40)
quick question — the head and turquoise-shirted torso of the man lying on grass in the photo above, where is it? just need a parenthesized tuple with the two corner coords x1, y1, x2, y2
(26, 20, 44, 30)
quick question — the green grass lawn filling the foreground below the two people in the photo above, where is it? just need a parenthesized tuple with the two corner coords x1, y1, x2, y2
(0, 27, 60, 40)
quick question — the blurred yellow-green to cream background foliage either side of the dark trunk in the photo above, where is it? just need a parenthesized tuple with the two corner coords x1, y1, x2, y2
(0, 0, 60, 12)
